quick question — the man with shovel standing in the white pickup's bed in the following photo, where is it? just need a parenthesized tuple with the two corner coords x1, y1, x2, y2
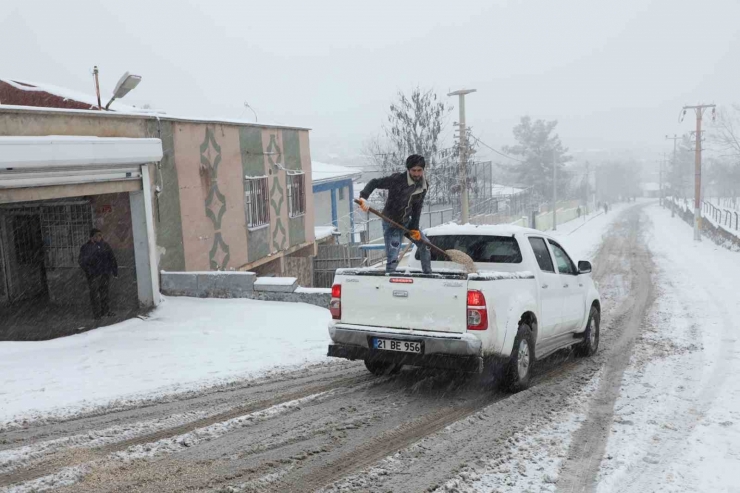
(360, 154, 432, 274)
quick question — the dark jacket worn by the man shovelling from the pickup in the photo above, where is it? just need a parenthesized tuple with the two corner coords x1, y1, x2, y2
(360, 171, 428, 229)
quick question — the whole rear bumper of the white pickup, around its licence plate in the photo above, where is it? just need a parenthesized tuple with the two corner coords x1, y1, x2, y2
(328, 324, 483, 372)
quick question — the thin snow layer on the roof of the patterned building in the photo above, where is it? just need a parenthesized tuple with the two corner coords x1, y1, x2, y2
(0, 77, 310, 130)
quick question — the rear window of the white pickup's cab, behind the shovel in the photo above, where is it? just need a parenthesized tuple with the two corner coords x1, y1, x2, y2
(416, 235, 522, 264)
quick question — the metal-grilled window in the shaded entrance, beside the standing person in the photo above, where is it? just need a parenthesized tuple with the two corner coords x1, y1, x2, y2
(41, 203, 93, 269)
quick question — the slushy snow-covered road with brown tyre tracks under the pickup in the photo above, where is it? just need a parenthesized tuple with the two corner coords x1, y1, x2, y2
(0, 204, 740, 492)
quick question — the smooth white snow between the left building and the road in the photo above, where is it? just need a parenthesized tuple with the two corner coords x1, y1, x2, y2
(0, 298, 331, 427)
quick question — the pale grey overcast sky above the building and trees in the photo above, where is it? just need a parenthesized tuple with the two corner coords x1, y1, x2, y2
(0, 0, 740, 164)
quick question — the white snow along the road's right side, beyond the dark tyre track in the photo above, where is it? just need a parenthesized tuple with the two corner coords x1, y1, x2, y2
(597, 205, 740, 493)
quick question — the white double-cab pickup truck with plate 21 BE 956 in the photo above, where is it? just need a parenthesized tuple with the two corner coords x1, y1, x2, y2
(328, 225, 601, 391)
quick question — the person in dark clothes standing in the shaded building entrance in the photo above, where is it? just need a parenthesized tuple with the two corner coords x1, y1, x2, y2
(78, 229, 118, 320)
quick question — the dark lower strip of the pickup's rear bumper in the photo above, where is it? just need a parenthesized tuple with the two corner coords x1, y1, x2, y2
(327, 344, 483, 373)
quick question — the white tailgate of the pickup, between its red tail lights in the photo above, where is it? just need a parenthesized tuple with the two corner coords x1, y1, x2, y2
(337, 275, 467, 333)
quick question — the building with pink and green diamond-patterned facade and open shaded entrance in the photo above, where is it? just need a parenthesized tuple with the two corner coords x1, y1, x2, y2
(0, 82, 316, 320)
